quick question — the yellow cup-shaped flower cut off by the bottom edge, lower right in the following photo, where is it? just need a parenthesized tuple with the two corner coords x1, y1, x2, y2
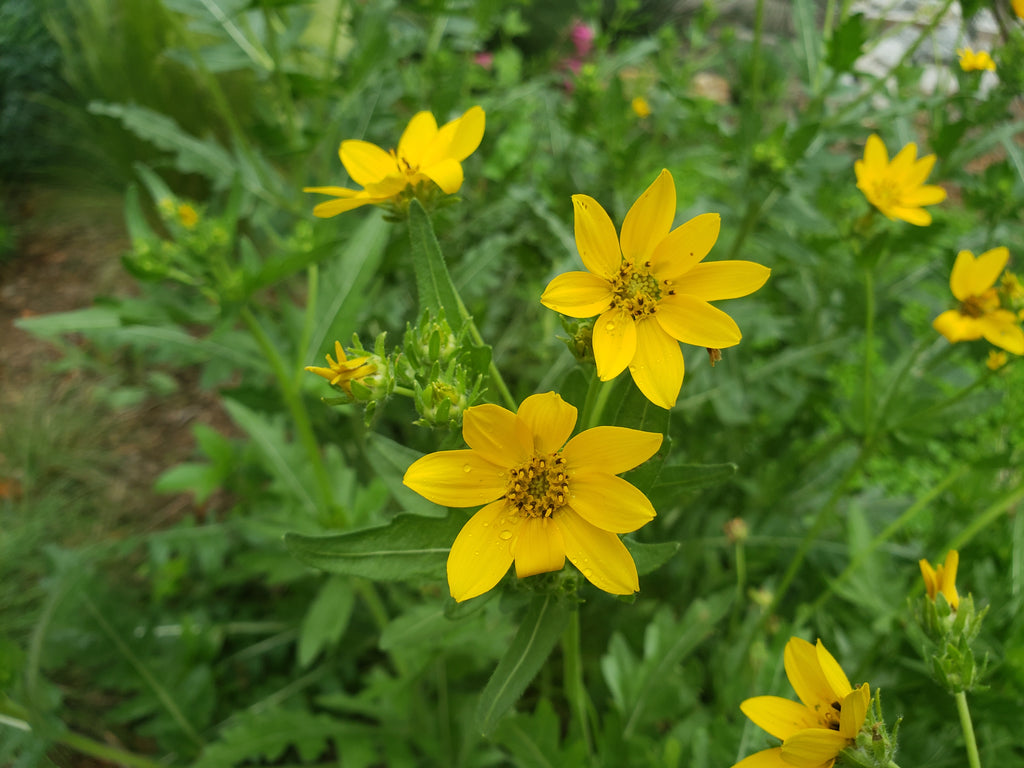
(733, 637, 871, 768)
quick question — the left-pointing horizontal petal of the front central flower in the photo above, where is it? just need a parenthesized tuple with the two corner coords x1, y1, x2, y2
(401, 448, 507, 507)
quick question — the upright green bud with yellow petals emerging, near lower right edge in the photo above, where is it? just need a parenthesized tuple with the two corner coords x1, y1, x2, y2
(908, 550, 988, 694)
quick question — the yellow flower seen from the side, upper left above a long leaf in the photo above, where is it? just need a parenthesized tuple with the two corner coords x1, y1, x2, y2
(303, 106, 484, 218)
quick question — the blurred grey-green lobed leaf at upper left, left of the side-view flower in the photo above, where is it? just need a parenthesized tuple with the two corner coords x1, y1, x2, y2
(88, 101, 236, 189)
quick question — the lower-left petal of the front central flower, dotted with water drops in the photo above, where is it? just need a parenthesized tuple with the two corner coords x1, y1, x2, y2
(447, 499, 512, 602)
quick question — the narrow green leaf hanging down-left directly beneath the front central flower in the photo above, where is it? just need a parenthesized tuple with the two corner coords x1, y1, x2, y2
(476, 594, 570, 735)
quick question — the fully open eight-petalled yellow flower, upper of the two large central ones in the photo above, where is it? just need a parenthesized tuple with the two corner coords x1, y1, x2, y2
(541, 170, 771, 409)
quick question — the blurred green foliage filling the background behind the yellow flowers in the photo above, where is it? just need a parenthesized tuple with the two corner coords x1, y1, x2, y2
(0, 0, 1024, 768)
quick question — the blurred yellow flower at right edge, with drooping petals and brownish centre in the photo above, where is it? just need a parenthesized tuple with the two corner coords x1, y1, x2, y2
(932, 247, 1024, 354)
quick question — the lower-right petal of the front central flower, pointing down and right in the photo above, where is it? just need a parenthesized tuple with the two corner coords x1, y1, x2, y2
(552, 507, 640, 595)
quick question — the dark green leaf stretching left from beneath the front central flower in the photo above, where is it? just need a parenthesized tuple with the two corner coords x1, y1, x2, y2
(285, 514, 466, 582)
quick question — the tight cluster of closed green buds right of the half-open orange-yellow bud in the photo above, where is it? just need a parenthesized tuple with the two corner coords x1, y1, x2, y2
(399, 310, 488, 429)
